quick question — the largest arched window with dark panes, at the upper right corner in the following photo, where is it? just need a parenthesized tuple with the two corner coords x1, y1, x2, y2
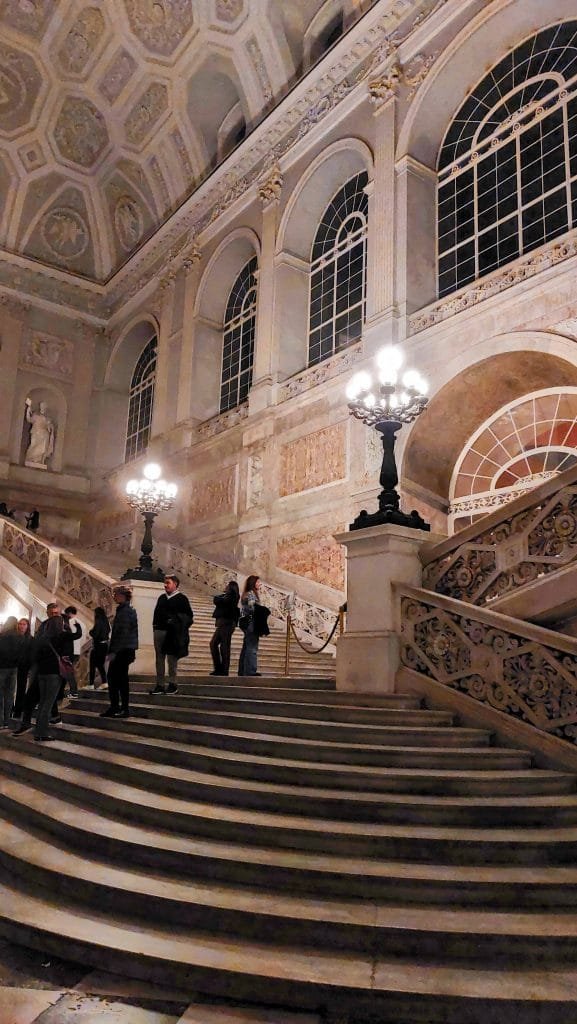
(438, 20, 577, 296)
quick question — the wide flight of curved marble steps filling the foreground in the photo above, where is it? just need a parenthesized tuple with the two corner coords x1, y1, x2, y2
(0, 677, 577, 1024)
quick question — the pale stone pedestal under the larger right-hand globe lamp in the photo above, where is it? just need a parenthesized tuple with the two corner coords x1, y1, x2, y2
(335, 525, 430, 693)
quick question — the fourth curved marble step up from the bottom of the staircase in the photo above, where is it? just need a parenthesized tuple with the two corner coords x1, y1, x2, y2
(0, 748, 577, 864)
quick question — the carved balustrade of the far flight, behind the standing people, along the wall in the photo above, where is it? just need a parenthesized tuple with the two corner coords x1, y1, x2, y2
(167, 545, 336, 640)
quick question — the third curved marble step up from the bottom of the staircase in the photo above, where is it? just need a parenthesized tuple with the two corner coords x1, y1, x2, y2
(0, 780, 577, 909)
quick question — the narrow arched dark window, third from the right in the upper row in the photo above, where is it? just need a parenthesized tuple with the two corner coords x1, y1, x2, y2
(220, 256, 257, 413)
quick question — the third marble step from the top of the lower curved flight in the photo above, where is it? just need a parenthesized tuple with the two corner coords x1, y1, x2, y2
(70, 691, 491, 746)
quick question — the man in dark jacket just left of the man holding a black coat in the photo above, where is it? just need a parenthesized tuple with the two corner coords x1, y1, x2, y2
(100, 587, 138, 718)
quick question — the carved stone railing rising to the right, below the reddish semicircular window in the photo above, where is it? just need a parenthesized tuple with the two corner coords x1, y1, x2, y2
(423, 467, 577, 605)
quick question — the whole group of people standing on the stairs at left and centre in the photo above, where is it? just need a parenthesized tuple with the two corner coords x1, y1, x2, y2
(0, 574, 270, 742)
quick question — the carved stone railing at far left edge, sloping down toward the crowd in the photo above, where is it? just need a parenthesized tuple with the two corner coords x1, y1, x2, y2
(0, 517, 114, 614)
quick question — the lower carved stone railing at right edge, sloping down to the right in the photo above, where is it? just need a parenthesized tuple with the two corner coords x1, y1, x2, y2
(395, 585, 577, 743)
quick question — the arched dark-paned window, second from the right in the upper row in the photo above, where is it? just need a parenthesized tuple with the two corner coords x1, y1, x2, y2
(308, 171, 369, 366)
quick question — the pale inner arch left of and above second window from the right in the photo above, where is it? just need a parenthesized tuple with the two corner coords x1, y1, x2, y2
(275, 138, 373, 380)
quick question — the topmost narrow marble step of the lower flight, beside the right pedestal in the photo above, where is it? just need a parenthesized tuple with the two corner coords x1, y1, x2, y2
(128, 676, 422, 711)
